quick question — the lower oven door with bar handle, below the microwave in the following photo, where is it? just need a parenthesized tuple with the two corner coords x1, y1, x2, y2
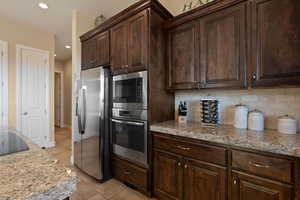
(111, 119, 148, 167)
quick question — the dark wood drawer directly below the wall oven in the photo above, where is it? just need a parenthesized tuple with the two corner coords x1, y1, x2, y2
(112, 158, 148, 191)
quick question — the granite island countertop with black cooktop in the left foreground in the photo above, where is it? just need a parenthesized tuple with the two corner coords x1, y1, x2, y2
(0, 128, 77, 200)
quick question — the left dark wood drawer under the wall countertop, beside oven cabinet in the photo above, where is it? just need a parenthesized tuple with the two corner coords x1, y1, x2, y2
(153, 136, 227, 166)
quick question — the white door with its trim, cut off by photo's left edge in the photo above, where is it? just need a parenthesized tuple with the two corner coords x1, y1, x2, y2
(0, 41, 8, 127)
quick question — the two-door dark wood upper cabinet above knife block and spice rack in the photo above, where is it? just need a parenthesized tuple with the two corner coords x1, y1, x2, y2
(168, 4, 246, 89)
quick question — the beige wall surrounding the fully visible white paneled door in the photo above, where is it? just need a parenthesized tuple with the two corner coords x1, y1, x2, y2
(0, 16, 55, 140)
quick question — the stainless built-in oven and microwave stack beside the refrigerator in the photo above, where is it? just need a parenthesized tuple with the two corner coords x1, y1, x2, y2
(111, 71, 148, 167)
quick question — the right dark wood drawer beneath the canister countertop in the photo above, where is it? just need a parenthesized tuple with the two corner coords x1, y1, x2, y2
(232, 150, 293, 183)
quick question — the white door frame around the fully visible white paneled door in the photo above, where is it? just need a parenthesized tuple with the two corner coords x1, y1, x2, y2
(16, 44, 51, 147)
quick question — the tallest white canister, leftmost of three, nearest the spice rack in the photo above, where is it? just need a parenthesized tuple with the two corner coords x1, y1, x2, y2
(234, 105, 249, 129)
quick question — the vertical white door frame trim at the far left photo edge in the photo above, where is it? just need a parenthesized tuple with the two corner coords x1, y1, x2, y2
(0, 40, 8, 127)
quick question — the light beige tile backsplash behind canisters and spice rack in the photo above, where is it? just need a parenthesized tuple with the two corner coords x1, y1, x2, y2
(175, 88, 300, 131)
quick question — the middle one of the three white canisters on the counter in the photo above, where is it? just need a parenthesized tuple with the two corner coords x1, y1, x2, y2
(248, 110, 265, 131)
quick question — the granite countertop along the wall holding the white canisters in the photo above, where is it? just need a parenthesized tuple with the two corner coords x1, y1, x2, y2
(150, 121, 300, 158)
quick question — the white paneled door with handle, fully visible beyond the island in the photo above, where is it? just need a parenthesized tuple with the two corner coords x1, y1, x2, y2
(17, 48, 49, 147)
